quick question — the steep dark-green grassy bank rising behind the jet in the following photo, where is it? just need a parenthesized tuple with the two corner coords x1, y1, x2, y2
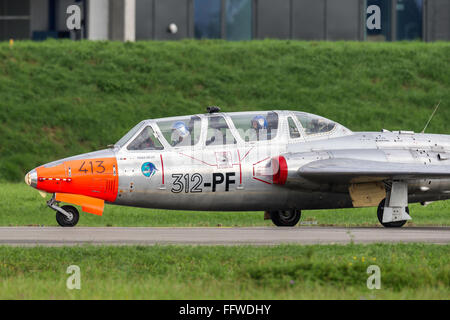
(0, 40, 450, 181)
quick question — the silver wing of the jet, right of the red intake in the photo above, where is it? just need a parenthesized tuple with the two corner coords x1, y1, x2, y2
(298, 158, 450, 183)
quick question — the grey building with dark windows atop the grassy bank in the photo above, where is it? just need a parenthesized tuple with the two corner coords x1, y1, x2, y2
(0, 0, 450, 41)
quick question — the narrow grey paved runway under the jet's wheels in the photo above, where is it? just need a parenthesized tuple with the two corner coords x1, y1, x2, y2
(0, 227, 450, 246)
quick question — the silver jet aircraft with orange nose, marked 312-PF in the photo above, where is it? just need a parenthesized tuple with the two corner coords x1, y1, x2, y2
(25, 107, 450, 227)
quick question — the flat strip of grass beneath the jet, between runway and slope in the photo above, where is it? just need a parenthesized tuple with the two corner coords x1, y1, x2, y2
(0, 183, 450, 227)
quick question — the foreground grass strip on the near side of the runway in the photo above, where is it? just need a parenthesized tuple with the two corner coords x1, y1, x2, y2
(0, 244, 450, 299)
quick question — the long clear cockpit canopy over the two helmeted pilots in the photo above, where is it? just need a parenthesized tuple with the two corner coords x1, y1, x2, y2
(115, 111, 351, 151)
